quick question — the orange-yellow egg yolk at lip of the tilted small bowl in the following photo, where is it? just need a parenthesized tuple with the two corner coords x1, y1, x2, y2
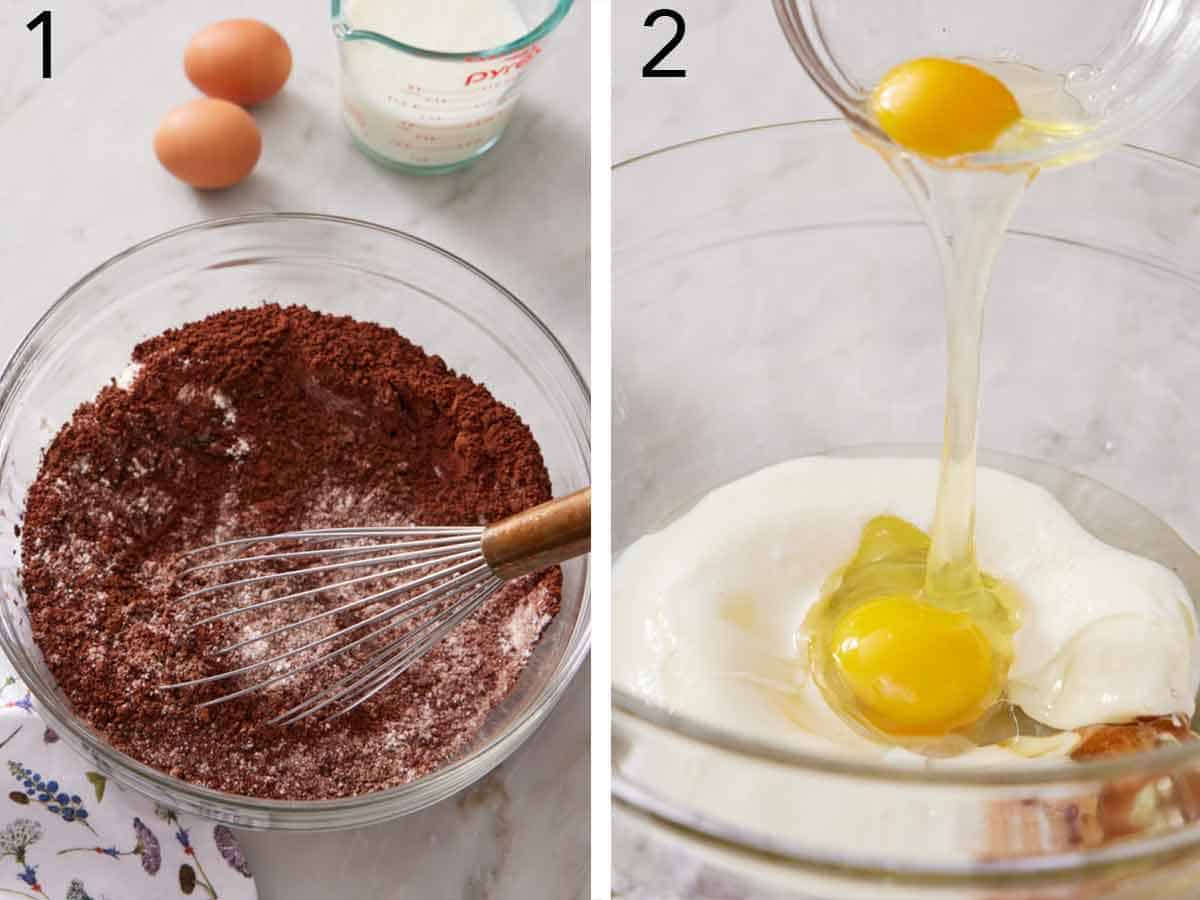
(871, 58, 1021, 157)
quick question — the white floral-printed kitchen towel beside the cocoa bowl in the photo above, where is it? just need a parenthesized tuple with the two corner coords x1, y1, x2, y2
(0, 654, 258, 900)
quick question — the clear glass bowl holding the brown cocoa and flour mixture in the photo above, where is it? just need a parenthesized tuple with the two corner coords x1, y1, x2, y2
(0, 214, 590, 830)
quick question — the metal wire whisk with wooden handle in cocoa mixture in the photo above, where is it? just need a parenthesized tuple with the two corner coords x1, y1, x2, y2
(163, 487, 592, 725)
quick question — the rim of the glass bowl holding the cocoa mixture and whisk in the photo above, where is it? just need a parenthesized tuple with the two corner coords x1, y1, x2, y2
(0, 211, 592, 830)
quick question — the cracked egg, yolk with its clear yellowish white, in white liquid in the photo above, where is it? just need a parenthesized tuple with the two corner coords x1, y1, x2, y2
(803, 515, 1021, 749)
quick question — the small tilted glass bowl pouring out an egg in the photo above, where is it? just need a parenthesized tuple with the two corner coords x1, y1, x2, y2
(773, 0, 1200, 166)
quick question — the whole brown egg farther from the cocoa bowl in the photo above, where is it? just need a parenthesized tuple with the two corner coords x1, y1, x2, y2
(184, 19, 292, 106)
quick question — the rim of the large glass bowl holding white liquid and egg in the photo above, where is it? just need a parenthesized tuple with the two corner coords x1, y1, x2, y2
(611, 116, 1200, 787)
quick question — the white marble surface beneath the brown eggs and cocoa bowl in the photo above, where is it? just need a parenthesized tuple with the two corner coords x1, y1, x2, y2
(0, 0, 589, 900)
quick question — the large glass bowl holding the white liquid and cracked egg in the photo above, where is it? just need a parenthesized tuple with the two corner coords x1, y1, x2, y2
(613, 121, 1200, 900)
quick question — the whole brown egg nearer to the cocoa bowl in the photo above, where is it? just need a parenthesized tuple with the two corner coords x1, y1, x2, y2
(154, 97, 263, 188)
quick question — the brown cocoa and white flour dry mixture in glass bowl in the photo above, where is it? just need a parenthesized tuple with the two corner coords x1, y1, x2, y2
(22, 305, 562, 799)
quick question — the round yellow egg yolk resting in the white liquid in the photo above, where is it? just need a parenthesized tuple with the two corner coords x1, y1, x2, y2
(833, 596, 995, 736)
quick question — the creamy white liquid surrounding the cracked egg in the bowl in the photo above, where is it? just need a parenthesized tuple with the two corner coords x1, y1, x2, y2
(613, 457, 1200, 764)
